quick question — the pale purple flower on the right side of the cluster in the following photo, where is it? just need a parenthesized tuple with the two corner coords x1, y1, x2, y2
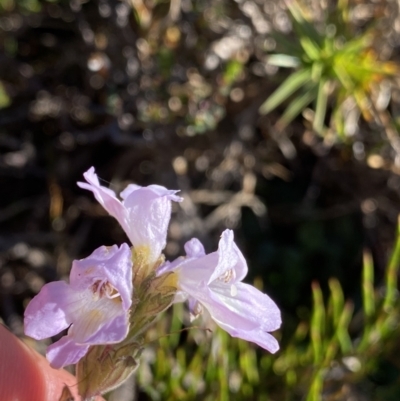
(158, 230, 281, 353)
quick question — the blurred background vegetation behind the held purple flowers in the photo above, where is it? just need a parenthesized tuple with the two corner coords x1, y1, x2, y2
(0, 0, 400, 401)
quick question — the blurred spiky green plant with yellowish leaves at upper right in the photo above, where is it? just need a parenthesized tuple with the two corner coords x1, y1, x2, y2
(260, 0, 399, 139)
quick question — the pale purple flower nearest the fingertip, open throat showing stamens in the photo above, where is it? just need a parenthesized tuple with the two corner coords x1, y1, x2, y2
(25, 244, 133, 368)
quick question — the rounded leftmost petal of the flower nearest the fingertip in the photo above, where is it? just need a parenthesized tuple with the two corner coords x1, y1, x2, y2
(24, 281, 72, 340)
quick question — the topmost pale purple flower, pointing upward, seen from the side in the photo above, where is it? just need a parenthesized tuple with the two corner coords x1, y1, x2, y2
(78, 167, 182, 262)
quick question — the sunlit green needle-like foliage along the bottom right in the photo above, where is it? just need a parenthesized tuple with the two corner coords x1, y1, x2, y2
(133, 217, 400, 401)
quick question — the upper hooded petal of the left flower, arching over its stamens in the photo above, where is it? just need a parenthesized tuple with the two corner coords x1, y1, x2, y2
(70, 244, 133, 310)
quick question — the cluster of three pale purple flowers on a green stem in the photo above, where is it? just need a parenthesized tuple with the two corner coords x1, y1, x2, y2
(25, 167, 281, 391)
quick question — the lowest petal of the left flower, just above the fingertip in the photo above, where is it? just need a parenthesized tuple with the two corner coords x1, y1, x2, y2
(46, 336, 90, 369)
